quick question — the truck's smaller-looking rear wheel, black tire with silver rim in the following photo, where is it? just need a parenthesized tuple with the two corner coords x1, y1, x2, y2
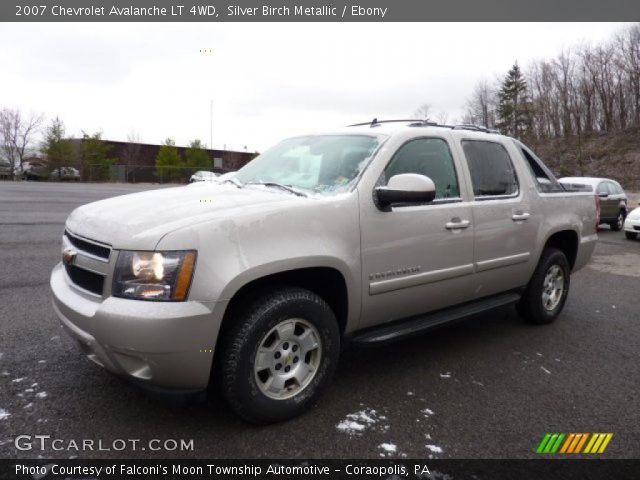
(517, 248, 571, 324)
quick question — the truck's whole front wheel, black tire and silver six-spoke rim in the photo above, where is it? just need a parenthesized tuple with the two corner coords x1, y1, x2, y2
(217, 287, 340, 423)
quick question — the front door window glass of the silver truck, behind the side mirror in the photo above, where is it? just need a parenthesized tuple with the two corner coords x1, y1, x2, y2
(382, 138, 460, 200)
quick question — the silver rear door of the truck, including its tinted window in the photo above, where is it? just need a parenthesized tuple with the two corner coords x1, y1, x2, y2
(461, 138, 540, 298)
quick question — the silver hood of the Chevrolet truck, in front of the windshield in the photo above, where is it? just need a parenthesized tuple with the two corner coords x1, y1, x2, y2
(66, 182, 302, 249)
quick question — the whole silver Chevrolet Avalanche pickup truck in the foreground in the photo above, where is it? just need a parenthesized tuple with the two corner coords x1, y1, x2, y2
(51, 121, 598, 422)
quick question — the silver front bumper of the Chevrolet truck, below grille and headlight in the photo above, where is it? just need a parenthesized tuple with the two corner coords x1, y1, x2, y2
(50, 264, 224, 391)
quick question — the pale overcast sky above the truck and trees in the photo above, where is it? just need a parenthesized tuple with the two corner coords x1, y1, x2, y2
(0, 23, 624, 151)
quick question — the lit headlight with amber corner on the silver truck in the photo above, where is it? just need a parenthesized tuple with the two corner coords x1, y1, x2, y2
(112, 250, 196, 302)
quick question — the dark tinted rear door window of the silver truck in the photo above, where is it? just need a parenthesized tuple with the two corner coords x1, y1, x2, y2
(462, 140, 518, 197)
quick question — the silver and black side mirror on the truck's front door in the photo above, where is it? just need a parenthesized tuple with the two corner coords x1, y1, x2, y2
(375, 173, 436, 210)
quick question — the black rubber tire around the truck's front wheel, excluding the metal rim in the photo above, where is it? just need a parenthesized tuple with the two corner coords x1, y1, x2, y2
(223, 289, 340, 422)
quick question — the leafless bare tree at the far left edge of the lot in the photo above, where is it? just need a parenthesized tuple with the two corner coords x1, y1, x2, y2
(0, 108, 44, 173)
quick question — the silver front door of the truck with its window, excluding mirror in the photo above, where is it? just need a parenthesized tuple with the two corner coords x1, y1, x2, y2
(359, 137, 473, 327)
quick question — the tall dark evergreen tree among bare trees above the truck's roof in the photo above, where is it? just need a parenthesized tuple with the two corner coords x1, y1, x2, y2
(497, 62, 531, 137)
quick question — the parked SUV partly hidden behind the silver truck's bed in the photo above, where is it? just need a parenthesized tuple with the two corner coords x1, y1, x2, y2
(559, 177, 627, 232)
